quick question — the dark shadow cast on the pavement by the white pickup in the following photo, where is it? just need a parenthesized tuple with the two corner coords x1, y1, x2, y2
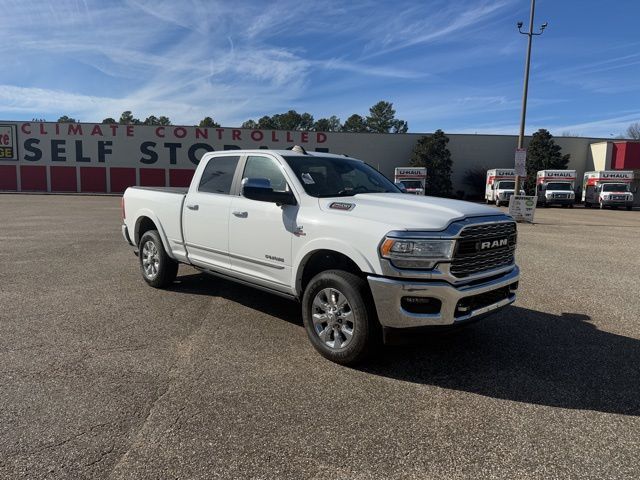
(171, 274, 640, 416)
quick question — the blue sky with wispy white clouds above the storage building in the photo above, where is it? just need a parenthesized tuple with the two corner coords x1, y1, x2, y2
(0, 0, 640, 137)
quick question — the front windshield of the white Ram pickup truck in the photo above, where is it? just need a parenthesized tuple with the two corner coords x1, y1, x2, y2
(284, 155, 402, 197)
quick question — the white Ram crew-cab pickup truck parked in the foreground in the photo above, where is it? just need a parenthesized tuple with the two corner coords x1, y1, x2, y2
(122, 147, 519, 364)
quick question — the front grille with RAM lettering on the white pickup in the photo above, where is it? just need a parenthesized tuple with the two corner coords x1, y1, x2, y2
(449, 222, 517, 278)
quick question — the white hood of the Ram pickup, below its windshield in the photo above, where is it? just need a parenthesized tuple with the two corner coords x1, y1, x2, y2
(319, 193, 503, 230)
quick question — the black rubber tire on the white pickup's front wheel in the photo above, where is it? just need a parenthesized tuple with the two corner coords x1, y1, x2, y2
(302, 270, 382, 365)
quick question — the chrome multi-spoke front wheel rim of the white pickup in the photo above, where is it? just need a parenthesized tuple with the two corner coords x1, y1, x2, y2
(311, 288, 354, 348)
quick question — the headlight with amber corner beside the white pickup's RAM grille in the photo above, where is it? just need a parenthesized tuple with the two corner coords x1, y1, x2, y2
(380, 238, 455, 268)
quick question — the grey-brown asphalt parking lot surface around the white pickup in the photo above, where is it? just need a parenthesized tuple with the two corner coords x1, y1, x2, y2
(0, 195, 640, 479)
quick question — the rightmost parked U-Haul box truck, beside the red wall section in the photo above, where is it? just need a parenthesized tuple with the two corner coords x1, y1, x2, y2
(582, 170, 633, 210)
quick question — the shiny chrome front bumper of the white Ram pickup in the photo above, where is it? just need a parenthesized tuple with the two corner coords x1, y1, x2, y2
(367, 266, 520, 328)
